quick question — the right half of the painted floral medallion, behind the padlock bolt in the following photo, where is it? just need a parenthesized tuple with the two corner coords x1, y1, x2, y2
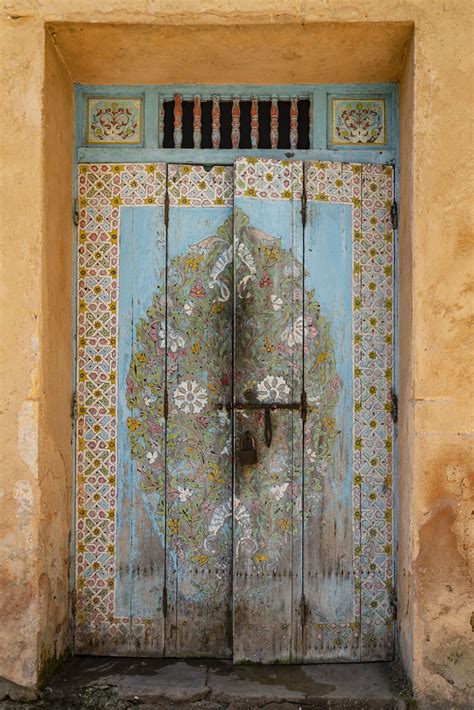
(234, 203, 339, 576)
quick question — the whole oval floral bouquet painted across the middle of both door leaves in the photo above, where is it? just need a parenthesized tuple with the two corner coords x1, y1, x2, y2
(127, 210, 338, 594)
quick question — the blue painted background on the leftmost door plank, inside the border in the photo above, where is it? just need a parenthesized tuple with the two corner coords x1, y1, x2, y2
(116, 207, 165, 656)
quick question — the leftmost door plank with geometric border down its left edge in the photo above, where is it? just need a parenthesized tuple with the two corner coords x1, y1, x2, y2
(76, 164, 166, 655)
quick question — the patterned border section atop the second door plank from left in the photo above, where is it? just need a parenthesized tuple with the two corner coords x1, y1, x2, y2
(168, 165, 234, 207)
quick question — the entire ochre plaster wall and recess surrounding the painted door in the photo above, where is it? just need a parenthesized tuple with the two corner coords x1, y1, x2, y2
(0, 0, 474, 707)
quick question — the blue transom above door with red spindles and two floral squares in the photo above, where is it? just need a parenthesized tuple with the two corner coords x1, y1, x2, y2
(75, 84, 398, 164)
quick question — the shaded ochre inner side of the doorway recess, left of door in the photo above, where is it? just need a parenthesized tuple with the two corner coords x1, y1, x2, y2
(39, 35, 74, 680)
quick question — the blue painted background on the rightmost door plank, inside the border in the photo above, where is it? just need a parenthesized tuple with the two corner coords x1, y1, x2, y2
(303, 201, 358, 661)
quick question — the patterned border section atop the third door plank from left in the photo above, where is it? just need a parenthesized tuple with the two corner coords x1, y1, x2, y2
(234, 157, 303, 200)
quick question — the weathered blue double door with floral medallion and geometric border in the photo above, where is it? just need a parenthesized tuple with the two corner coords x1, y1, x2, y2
(76, 158, 393, 663)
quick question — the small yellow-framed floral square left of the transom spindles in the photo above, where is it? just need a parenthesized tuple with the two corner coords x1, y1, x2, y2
(86, 96, 143, 146)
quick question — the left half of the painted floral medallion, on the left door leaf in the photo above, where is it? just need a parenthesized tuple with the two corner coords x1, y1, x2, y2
(127, 211, 232, 599)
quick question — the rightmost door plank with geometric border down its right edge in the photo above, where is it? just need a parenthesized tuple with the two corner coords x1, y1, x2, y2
(303, 162, 394, 661)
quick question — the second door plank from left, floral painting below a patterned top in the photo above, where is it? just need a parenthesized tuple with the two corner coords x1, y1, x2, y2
(165, 165, 233, 657)
